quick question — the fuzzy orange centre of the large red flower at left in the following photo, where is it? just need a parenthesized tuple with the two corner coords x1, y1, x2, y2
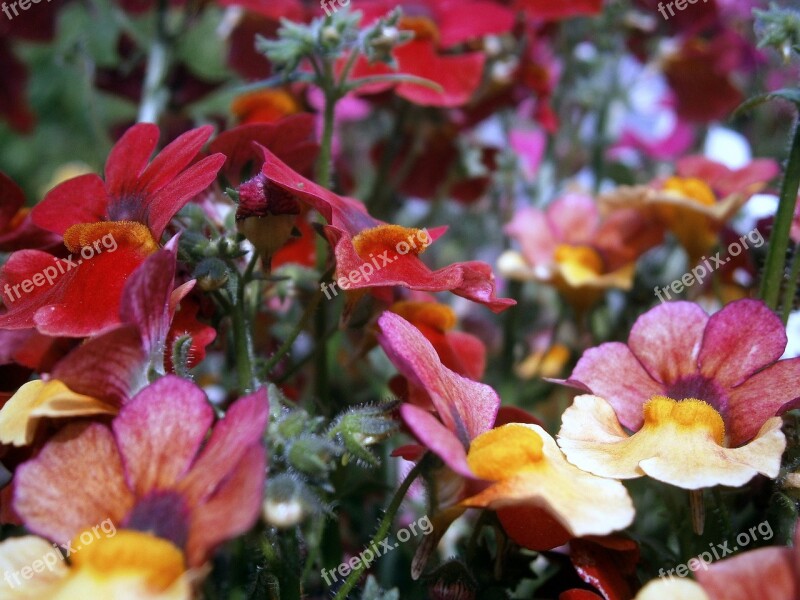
(64, 221, 158, 255)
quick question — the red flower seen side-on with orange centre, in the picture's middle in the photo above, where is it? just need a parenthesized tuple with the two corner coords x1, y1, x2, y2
(261, 148, 516, 312)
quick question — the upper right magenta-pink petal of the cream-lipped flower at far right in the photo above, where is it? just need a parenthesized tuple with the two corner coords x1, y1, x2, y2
(697, 299, 787, 387)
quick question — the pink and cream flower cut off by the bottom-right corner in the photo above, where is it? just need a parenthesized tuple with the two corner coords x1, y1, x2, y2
(636, 528, 800, 600)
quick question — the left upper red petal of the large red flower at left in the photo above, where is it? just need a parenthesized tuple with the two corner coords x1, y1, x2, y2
(31, 174, 108, 236)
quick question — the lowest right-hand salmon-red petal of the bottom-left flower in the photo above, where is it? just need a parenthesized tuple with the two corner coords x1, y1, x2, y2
(186, 445, 267, 566)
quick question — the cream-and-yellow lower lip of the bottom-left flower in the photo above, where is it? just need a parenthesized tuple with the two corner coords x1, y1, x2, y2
(0, 530, 192, 600)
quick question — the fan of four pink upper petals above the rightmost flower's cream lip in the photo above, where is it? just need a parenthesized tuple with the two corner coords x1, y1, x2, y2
(566, 300, 800, 446)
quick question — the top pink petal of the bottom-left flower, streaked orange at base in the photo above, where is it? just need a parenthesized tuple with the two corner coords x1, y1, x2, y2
(113, 375, 214, 497)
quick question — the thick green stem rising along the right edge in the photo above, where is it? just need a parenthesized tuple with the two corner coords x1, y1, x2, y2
(760, 120, 800, 310)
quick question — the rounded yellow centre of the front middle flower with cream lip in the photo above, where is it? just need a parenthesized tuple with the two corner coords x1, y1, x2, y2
(467, 423, 543, 481)
